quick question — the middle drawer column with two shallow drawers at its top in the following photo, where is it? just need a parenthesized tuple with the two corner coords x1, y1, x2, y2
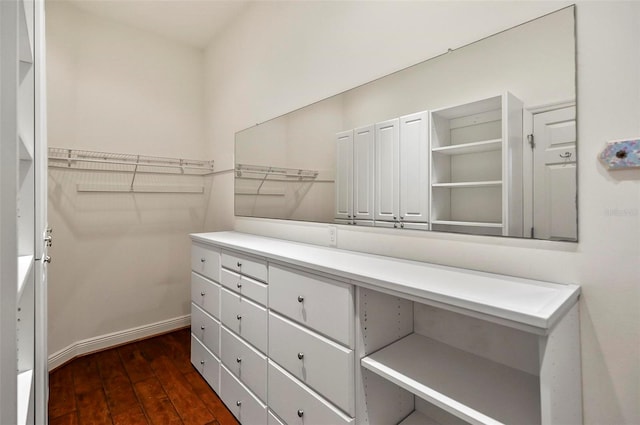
(219, 250, 268, 424)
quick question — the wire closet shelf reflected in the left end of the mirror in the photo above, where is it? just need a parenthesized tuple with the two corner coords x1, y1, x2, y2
(235, 164, 329, 196)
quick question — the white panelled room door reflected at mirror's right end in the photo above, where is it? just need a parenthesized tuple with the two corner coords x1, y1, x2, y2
(533, 106, 578, 240)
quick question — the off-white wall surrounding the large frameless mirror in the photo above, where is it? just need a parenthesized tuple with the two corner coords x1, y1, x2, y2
(206, 1, 640, 425)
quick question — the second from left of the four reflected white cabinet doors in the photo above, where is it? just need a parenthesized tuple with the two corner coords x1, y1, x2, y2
(353, 125, 375, 220)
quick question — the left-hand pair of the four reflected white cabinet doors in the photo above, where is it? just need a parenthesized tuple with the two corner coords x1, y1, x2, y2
(336, 126, 374, 226)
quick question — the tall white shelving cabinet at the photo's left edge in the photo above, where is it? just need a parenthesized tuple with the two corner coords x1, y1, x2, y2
(0, 0, 50, 424)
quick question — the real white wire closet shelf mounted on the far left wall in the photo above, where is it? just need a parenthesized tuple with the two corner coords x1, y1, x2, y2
(49, 147, 214, 193)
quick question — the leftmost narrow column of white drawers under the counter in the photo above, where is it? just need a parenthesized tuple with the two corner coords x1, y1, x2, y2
(191, 244, 220, 392)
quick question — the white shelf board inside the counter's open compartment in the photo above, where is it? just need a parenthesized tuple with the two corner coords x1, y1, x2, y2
(361, 333, 541, 424)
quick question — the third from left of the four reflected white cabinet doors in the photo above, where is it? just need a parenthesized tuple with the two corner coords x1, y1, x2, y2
(375, 118, 400, 221)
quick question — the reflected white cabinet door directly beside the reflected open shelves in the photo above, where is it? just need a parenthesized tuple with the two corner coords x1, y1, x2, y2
(400, 112, 429, 223)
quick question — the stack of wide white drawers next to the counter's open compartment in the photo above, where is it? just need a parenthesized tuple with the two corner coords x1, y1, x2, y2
(268, 264, 355, 425)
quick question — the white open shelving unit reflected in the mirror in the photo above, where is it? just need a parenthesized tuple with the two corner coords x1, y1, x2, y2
(431, 93, 523, 236)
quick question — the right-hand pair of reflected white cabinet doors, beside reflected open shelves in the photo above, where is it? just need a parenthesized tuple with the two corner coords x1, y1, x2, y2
(375, 112, 429, 230)
